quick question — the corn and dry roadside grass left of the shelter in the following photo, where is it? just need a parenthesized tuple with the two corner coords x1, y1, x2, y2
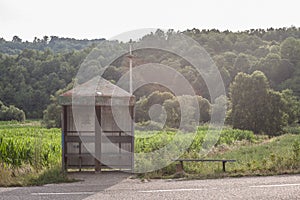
(0, 121, 70, 186)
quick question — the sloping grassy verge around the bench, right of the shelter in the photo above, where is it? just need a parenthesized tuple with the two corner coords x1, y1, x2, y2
(138, 134, 300, 179)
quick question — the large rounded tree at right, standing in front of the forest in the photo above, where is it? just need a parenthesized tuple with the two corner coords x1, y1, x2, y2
(229, 71, 286, 135)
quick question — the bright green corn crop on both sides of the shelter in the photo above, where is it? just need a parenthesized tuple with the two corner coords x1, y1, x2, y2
(0, 122, 256, 168)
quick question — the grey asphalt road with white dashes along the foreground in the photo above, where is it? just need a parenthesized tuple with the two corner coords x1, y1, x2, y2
(0, 173, 300, 200)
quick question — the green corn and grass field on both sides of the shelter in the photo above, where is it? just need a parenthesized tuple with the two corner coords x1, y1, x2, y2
(0, 121, 300, 186)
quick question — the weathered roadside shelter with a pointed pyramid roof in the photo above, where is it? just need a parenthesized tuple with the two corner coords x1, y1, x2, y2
(59, 77, 135, 171)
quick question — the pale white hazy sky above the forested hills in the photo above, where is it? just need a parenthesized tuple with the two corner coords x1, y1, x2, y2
(0, 0, 300, 41)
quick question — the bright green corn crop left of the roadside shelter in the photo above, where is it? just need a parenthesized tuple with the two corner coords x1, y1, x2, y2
(0, 125, 61, 168)
